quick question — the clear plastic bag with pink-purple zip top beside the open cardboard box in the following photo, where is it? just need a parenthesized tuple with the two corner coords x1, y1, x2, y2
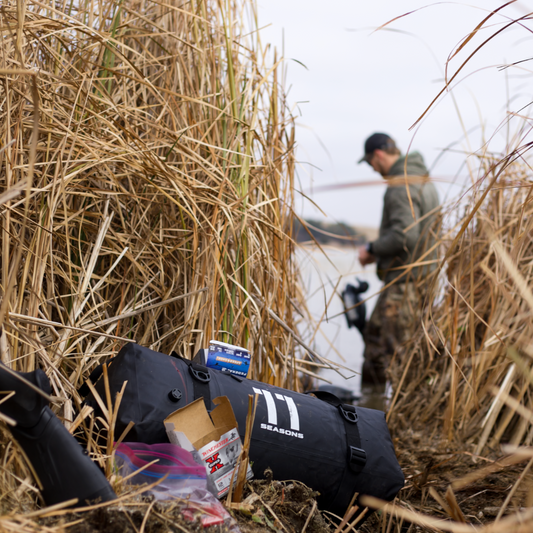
(115, 442, 239, 533)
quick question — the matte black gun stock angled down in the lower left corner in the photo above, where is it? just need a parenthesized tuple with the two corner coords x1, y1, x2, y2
(0, 363, 116, 506)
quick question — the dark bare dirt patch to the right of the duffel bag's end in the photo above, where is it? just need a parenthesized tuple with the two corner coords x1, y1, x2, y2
(358, 430, 533, 533)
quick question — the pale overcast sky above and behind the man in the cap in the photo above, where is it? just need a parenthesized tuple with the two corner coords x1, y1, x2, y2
(258, 0, 533, 226)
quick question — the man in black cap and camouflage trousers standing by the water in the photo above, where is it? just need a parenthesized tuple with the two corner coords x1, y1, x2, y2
(359, 133, 439, 384)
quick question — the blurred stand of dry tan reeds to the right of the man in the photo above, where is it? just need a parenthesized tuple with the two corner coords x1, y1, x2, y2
(386, 156, 533, 453)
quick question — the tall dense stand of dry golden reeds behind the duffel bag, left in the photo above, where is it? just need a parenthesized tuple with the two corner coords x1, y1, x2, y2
(0, 0, 330, 520)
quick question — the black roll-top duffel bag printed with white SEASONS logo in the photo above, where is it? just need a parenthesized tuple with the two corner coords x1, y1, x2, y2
(86, 344, 404, 516)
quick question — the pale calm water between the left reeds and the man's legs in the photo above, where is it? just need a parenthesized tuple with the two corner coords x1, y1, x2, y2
(297, 246, 383, 408)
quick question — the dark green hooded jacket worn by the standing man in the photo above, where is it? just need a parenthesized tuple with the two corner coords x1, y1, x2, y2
(372, 152, 439, 283)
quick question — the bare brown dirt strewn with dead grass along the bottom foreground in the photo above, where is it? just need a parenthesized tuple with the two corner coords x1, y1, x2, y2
(41, 416, 533, 533)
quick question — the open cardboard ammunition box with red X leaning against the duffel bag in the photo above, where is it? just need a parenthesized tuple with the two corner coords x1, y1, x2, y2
(165, 396, 253, 498)
